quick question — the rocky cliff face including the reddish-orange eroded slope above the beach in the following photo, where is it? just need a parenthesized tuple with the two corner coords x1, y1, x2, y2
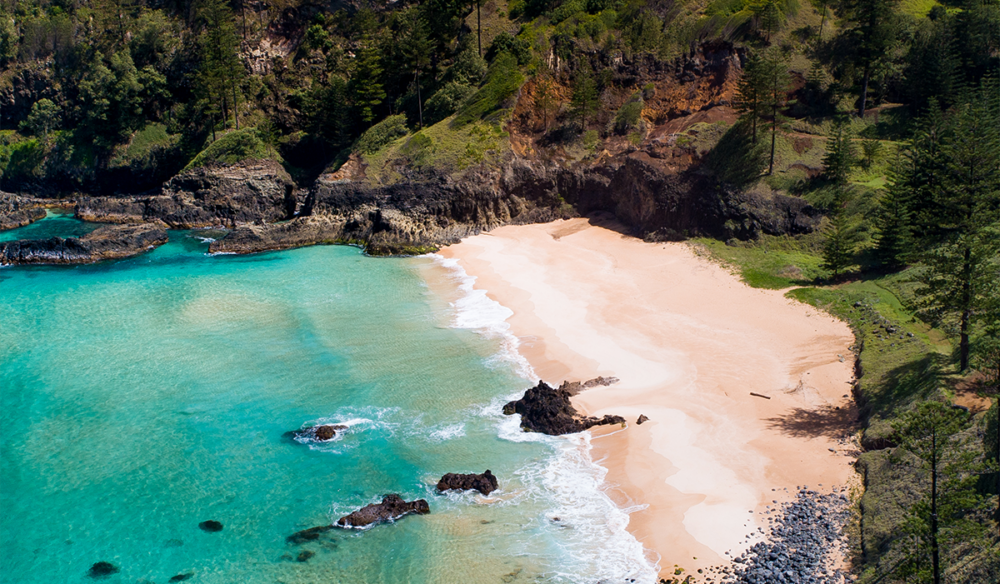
(3, 42, 820, 254)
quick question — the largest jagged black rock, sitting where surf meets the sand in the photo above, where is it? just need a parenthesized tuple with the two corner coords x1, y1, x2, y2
(503, 381, 625, 436)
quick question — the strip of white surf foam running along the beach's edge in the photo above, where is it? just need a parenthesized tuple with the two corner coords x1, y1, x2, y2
(432, 254, 658, 582)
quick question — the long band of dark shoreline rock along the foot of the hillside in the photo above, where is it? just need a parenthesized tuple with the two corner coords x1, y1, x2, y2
(0, 146, 820, 263)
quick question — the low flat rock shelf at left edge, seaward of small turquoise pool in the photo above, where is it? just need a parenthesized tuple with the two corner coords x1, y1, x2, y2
(0, 223, 168, 264)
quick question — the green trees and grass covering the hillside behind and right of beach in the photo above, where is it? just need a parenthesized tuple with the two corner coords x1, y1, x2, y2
(0, 0, 1000, 582)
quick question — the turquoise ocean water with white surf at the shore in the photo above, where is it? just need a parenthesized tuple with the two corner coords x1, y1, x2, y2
(0, 216, 655, 583)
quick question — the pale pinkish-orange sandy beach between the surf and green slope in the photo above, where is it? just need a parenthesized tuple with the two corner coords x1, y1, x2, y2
(441, 219, 854, 577)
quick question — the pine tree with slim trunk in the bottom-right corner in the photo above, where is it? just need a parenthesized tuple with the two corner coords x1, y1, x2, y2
(893, 401, 986, 584)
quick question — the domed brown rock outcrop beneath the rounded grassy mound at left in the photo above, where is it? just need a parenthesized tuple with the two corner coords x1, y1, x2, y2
(76, 160, 297, 229)
